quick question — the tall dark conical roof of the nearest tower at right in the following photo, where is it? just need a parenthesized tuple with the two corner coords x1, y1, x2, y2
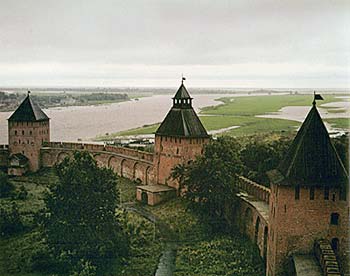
(268, 105, 348, 187)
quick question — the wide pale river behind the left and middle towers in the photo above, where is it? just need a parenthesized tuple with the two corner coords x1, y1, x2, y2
(0, 94, 227, 144)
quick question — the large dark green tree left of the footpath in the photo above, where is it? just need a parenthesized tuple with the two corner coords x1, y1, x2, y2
(44, 151, 127, 266)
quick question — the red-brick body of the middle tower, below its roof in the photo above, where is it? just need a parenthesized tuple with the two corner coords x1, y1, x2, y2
(154, 135, 209, 189)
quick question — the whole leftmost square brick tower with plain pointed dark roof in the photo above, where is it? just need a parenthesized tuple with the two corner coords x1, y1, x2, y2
(8, 91, 50, 172)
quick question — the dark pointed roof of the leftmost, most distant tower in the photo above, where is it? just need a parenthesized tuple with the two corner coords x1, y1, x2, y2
(8, 94, 49, 122)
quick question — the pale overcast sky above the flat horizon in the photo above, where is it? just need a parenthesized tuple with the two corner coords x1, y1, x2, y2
(0, 0, 350, 88)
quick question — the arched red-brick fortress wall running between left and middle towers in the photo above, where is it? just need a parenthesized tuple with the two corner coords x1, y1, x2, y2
(40, 142, 154, 184)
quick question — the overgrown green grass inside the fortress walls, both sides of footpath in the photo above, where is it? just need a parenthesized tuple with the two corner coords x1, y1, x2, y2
(0, 170, 264, 276)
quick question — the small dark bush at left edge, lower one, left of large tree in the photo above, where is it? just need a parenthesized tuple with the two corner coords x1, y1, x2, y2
(0, 203, 23, 236)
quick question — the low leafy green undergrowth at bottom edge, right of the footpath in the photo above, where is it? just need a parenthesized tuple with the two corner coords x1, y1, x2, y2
(174, 235, 264, 276)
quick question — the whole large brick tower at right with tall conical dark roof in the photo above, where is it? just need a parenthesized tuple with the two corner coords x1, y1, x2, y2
(267, 102, 349, 276)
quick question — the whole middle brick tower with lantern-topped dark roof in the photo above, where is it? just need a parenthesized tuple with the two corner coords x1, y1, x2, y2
(154, 81, 209, 189)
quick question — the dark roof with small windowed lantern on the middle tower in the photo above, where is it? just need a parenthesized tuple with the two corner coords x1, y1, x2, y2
(156, 83, 209, 138)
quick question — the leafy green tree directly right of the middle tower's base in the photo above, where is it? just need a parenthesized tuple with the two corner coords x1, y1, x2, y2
(183, 137, 242, 231)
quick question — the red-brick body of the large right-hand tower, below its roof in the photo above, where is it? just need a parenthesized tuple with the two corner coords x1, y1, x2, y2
(267, 185, 349, 275)
